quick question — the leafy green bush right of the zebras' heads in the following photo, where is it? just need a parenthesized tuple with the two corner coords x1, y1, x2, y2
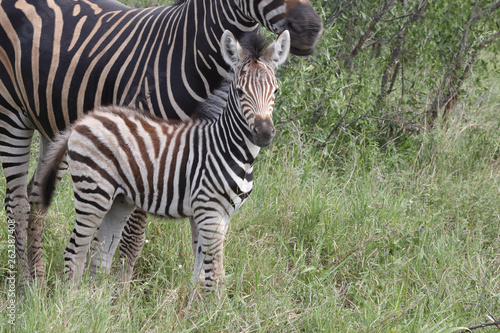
(278, 0, 500, 150)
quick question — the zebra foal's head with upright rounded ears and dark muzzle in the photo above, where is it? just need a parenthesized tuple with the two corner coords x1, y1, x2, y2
(221, 30, 290, 147)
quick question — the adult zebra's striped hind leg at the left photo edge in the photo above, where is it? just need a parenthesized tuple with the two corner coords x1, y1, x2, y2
(0, 107, 33, 291)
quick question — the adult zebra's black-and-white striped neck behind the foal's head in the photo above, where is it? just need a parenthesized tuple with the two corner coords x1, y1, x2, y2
(155, 0, 258, 120)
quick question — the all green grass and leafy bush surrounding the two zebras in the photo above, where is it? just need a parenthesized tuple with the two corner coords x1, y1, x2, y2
(0, 0, 500, 332)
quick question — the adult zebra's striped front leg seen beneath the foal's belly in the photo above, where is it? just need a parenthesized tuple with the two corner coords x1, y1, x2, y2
(119, 208, 148, 288)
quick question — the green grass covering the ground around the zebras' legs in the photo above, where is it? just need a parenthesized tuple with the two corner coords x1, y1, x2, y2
(0, 1, 500, 332)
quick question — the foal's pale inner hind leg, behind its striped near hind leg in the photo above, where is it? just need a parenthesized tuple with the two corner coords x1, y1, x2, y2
(90, 195, 135, 277)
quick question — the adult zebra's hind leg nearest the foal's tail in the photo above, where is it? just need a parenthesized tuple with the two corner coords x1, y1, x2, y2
(27, 136, 68, 285)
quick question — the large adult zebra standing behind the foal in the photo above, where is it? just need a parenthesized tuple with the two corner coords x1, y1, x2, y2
(0, 0, 322, 286)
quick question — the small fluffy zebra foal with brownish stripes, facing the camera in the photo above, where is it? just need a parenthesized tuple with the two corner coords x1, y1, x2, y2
(41, 30, 290, 288)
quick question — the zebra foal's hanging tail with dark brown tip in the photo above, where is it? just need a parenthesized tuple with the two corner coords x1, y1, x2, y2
(40, 129, 72, 211)
